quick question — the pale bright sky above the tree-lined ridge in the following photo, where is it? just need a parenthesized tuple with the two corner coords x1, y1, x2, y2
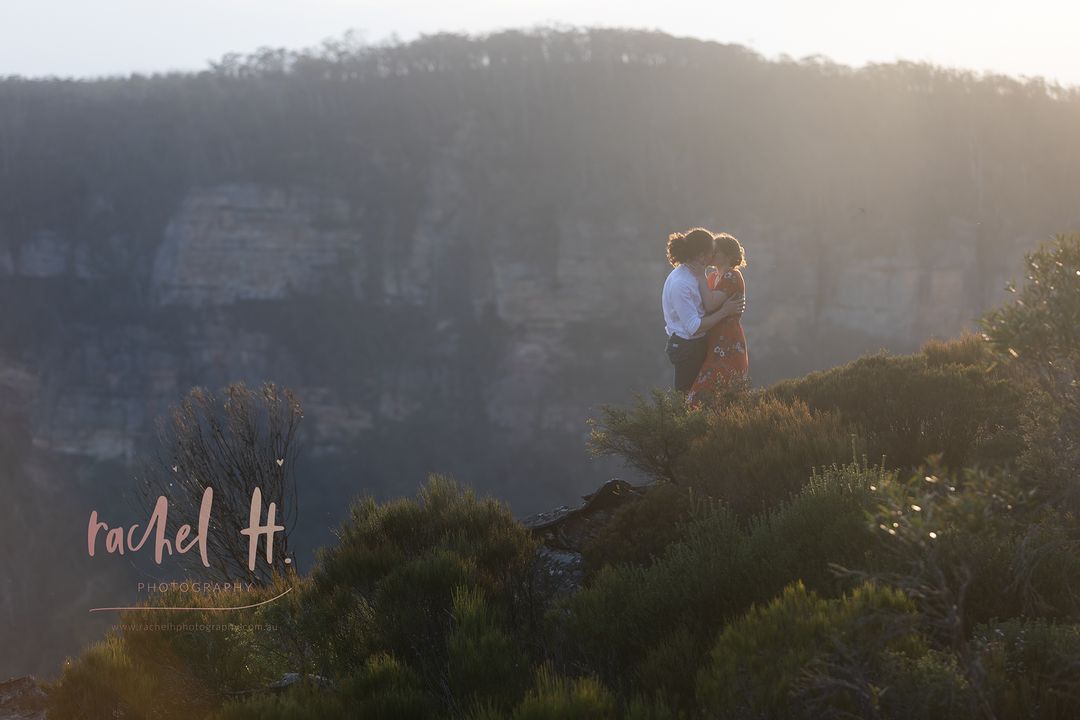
(0, 0, 1080, 85)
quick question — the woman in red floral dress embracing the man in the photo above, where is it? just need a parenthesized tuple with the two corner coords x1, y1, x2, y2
(686, 232, 750, 405)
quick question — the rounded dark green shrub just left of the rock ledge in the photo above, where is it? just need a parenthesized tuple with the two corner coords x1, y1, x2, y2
(312, 475, 539, 688)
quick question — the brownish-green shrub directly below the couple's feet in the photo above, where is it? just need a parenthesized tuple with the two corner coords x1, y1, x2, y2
(590, 392, 852, 516)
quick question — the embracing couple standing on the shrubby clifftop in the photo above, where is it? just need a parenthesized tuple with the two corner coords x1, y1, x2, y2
(662, 228, 748, 404)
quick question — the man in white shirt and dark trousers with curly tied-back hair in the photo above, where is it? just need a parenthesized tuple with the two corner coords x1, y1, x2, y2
(661, 228, 746, 392)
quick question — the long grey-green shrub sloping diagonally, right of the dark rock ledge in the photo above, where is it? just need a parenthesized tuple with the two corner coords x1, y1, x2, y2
(553, 465, 883, 709)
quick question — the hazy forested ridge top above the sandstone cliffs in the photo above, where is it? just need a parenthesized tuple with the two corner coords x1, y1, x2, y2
(0, 30, 1080, 289)
